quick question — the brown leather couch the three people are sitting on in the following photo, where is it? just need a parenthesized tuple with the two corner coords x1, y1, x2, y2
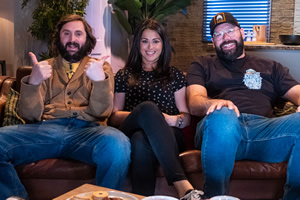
(0, 66, 287, 200)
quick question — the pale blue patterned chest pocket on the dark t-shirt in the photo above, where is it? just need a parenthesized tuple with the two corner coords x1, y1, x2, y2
(243, 69, 262, 90)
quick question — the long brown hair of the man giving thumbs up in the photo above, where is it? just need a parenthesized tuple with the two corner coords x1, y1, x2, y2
(51, 15, 97, 56)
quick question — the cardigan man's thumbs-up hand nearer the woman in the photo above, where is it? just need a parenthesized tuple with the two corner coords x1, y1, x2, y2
(85, 56, 109, 81)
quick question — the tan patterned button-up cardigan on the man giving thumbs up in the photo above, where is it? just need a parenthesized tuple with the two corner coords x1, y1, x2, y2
(18, 57, 114, 124)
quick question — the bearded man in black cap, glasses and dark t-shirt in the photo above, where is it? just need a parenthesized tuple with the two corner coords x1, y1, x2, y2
(187, 12, 300, 200)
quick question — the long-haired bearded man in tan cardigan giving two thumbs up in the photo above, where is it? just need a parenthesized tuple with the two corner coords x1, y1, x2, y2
(0, 15, 130, 199)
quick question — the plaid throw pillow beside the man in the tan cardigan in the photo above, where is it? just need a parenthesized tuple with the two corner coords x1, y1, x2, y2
(2, 88, 25, 126)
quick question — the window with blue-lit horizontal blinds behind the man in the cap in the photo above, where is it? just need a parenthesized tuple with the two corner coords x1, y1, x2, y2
(202, 0, 271, 42)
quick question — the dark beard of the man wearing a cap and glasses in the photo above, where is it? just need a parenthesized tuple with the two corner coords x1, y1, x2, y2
(216, 37, 244, 63)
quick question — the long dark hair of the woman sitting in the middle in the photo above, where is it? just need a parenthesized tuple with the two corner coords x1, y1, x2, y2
(124, 19, 172, 86)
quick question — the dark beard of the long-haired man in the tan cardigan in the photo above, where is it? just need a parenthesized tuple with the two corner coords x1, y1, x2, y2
(57, 42, 89, 63)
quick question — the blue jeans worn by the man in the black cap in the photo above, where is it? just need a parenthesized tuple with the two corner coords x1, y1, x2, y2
(195, 107, 300, 200)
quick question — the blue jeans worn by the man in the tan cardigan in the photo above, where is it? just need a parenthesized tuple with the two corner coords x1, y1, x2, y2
(0, 118, 130, 199)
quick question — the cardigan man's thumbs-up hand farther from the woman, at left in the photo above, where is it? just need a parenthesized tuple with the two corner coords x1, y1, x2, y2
(28, 52, 52, 85)
